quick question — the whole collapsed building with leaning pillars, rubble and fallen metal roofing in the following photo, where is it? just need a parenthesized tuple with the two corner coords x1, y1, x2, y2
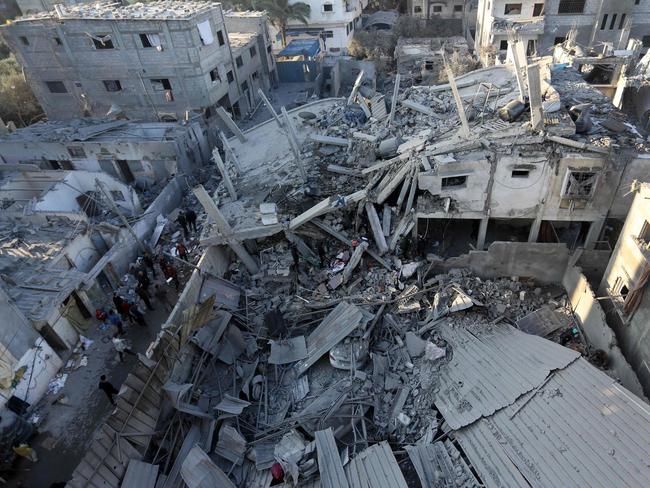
(62, 65, 650, 488)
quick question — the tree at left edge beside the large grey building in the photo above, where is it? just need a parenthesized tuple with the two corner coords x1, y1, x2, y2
(0, 54, 43, 127)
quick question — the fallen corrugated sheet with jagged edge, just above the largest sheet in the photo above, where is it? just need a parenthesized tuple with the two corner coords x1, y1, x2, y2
(435, 324, 580, 429)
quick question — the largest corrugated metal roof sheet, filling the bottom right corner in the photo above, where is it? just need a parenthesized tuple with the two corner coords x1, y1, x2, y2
(456, 359, 650, 488)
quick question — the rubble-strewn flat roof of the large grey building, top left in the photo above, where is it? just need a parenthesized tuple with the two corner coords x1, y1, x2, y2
(16, 0, 221, 22)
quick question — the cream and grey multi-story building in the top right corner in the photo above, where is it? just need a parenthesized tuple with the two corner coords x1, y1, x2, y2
(474, 0, 650, 64)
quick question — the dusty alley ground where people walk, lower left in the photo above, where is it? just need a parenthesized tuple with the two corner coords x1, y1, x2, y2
(4, 270, 189, 488)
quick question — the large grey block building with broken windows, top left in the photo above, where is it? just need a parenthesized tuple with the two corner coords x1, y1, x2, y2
(0, 0, 272, 121)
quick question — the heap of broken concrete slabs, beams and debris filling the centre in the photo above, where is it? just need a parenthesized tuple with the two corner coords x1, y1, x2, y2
(59, 55, 648, 487)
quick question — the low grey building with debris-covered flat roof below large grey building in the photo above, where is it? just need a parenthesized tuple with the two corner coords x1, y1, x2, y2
(0, 117, 210, 188)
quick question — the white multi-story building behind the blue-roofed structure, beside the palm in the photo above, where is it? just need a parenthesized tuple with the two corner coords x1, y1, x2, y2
(275, 0, 368, 53)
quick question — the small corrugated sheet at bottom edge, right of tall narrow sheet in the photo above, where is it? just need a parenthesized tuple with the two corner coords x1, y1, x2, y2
(345, 441, 408, 488)
